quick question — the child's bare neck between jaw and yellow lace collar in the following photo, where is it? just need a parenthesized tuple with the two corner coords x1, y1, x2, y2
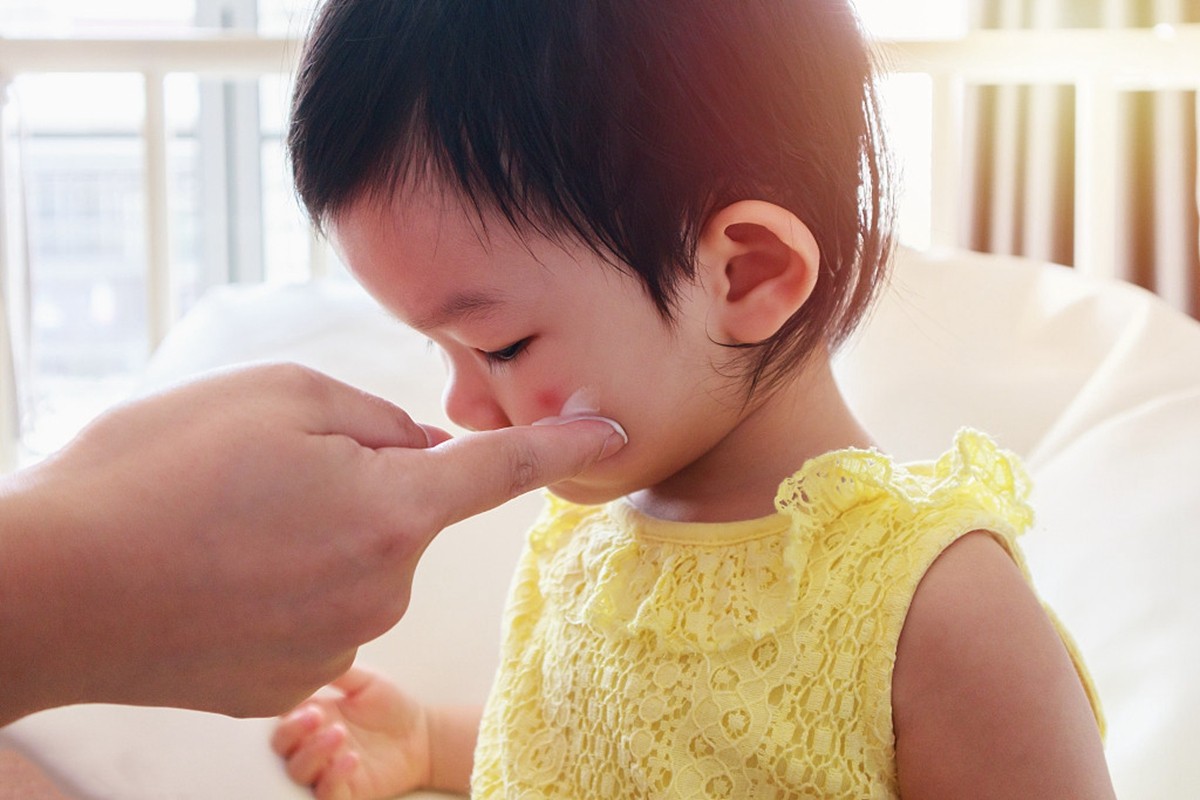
(630, 356, 874, 522)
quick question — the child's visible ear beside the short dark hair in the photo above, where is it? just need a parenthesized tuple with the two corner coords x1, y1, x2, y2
(697, 200, 821, 344)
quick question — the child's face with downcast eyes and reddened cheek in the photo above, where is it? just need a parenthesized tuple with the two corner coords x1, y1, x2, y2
(334, 187, 742, 503)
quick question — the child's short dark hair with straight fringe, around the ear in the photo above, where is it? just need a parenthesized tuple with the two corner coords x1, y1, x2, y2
(288, 0, 893, 387)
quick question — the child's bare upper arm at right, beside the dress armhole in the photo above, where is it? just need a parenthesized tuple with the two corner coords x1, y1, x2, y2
(892, 531, 1114, 798)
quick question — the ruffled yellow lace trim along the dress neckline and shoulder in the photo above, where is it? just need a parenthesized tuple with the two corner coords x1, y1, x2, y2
(530, 431, 1032, 652)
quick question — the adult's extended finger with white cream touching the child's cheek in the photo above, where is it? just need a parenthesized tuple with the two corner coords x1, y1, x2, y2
(420, 417, 625, 527)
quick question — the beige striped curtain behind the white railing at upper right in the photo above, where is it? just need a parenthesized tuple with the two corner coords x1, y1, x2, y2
(960, 0, 1200, 318)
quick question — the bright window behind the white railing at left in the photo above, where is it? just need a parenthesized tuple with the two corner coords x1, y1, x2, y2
(0, 0, 326, 461)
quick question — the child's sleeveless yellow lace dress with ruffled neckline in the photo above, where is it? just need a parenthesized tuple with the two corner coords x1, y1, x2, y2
(472, 432, 1099, 800)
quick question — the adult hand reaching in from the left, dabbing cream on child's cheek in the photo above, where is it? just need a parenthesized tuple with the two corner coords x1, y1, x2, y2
(0, 365, 623, 724)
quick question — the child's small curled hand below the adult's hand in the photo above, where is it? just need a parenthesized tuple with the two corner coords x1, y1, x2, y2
(271, 667, 431, 800)
